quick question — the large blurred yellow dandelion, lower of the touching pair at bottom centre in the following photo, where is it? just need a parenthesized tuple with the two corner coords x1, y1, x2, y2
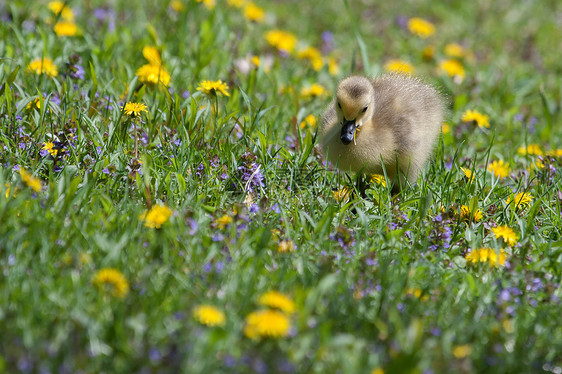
(244, 309, 291, 339)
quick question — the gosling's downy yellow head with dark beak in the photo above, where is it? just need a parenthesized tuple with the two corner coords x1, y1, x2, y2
(336, 76, 375, 145)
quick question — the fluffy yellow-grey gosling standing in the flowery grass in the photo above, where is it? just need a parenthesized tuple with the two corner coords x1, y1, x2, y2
(319, 74, 444, 190)
